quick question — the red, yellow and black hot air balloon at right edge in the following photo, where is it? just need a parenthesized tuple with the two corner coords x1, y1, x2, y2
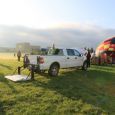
(96, 37, 115, 63)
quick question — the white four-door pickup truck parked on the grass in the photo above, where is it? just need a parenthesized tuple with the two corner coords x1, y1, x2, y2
(24, 48, 87, 76)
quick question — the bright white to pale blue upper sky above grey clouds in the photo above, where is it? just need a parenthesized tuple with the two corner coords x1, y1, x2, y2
(0, 0, 115, 29)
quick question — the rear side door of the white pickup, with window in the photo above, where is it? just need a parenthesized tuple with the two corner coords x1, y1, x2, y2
(66, 49, 76, 67)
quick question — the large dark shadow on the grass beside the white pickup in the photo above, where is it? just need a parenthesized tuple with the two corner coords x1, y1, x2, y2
(29, 69, 115, 113)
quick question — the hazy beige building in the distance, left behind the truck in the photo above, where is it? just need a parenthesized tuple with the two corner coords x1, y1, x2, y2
(16, 42, 40, 53)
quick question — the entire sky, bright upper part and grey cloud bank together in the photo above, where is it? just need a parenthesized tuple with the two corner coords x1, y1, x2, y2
(0, 0, 115, 46)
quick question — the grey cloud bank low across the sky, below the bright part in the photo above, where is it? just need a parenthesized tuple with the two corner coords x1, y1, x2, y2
(0, 25, 115, 48)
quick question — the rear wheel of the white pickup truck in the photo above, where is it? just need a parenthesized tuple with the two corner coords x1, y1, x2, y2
(48, 64, 59, 77)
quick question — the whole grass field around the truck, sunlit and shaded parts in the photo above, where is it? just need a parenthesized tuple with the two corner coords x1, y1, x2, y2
(0, 53, 115, 115)
